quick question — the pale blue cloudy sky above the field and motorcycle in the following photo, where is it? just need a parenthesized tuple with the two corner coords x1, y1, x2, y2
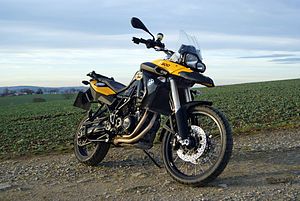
(0, 0, 300, 87)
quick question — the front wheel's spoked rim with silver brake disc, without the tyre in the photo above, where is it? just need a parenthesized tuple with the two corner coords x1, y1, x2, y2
(166, 111, 224, 178)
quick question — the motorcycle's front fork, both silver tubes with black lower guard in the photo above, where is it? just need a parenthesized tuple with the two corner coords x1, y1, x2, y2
(169, 78, 191, 145)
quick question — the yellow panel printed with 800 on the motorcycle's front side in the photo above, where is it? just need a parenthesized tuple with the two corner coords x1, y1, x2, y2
(152, 59, 193, 76)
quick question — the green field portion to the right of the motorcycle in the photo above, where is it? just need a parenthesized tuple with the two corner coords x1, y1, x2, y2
(197, 79, 300, 133)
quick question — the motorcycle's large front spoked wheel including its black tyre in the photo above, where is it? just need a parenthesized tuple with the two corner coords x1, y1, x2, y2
(162, 106, 232, 186)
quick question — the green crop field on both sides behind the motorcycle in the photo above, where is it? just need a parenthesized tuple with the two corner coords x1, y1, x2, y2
(0, 79, 300, 154)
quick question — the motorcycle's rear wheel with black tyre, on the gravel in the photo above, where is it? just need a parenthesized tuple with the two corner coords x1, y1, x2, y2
(74, 116, 110, 166)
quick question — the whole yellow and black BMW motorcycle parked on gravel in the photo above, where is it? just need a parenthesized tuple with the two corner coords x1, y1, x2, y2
(74, 17, 233, 186)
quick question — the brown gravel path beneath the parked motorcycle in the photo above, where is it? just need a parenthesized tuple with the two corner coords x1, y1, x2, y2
(0, 128, 300, 200)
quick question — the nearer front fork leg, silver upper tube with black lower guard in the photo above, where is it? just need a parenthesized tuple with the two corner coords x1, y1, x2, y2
(170, 78, 188, 140)
